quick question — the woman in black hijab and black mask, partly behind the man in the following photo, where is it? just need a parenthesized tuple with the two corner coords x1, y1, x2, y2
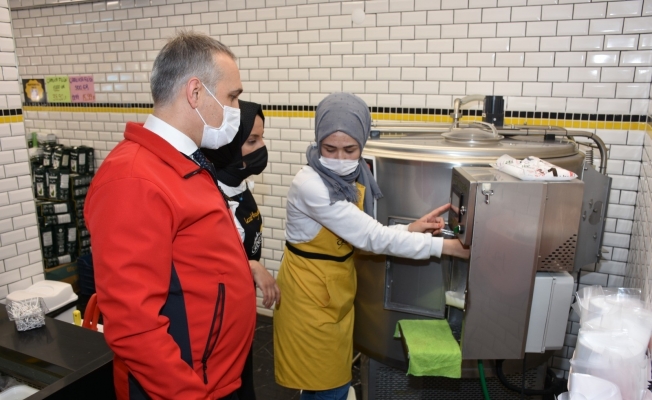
(202, 100, 281, 400)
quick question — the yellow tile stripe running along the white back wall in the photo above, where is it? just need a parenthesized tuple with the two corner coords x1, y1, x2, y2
(16, 105, 652, 130)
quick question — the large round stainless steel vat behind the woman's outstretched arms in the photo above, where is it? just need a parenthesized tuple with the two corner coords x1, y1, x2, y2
(354, 128, 604, 369)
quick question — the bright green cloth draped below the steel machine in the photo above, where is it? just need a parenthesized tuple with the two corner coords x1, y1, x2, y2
(394, 319, 462, 378)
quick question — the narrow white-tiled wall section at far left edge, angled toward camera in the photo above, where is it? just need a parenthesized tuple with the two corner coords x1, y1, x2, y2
(0, 1, 44, 301)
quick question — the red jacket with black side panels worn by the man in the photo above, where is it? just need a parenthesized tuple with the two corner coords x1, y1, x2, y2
(84, 123, 256, 400)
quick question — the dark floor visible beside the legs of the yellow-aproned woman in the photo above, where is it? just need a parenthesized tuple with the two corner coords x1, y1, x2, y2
(251, 315, 362, 400)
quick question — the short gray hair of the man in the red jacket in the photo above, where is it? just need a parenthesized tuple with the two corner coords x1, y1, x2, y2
(150, 31, 236, 106)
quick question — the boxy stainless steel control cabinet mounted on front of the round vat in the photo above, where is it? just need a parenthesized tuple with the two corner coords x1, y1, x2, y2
(449, 167, 584, 360)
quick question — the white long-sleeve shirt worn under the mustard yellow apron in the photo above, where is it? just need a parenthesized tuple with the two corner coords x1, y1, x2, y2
(285, 166, 444, 259)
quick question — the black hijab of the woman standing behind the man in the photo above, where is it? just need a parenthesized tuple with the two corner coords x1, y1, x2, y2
(201, 100, 265, 187)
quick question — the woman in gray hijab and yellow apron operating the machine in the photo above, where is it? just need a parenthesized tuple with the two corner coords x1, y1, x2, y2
(274, 93, 469, 400)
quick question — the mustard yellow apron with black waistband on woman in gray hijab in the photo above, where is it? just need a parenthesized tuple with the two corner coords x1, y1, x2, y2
(274, 183, 365, 390)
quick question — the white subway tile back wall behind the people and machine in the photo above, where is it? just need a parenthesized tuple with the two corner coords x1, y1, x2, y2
(7, 0, 652, 370)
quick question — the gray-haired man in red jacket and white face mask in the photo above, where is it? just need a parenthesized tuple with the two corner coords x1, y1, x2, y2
(85, 32, 256, 400)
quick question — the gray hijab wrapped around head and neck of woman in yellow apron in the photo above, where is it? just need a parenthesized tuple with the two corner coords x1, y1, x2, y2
(306, 93, 383, 217)
